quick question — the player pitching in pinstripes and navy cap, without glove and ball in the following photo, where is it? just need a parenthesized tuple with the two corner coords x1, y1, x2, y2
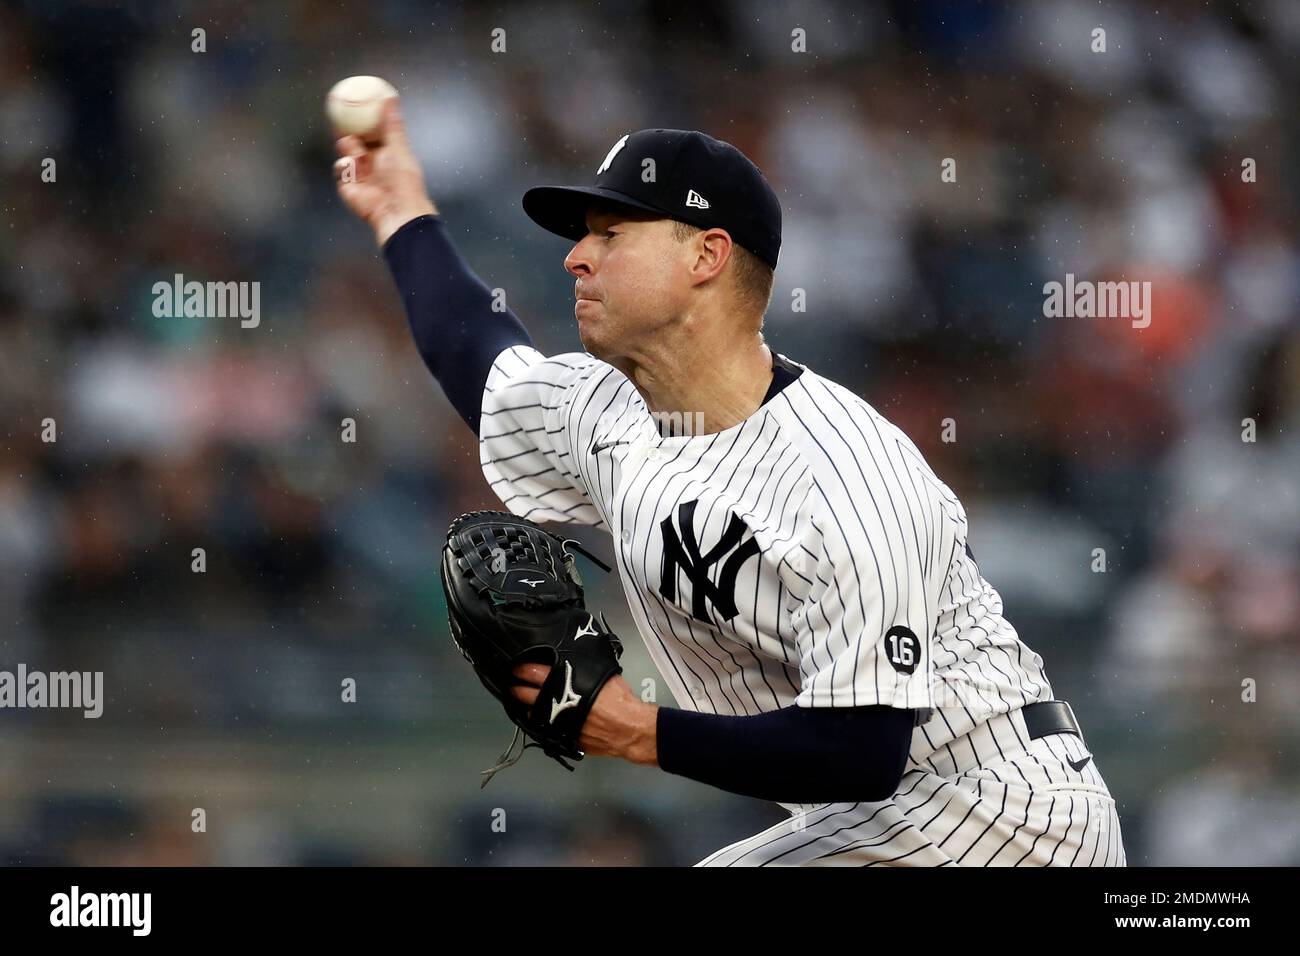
(335, 101, 1126, 866)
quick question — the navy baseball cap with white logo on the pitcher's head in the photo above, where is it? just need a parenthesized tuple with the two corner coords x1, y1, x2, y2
(524, 130, 781, 269)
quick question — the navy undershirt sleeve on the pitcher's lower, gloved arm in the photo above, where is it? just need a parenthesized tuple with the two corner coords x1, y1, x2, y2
(657, 705, 917, 804)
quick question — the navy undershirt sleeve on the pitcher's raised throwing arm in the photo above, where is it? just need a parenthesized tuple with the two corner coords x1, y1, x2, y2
(384, 216, 533, 436)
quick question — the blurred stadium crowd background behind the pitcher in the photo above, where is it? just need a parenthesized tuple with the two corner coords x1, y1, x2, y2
(0, 0, 1300, 865)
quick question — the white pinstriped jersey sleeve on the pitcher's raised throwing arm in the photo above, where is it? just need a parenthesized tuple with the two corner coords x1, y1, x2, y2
(478, 346, 605, 527)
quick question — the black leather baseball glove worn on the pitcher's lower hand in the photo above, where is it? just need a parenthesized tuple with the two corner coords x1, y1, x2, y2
(442, 511, 623, 787)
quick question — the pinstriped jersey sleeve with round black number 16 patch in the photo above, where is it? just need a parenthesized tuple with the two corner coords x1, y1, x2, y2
(796, 434, 953, 709)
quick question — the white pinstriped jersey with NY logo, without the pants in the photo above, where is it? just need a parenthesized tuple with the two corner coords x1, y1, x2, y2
(480, 346, 1052, 766)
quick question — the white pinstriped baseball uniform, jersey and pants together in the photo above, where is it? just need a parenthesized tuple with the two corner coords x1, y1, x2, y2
(480, 346, 1125, 866)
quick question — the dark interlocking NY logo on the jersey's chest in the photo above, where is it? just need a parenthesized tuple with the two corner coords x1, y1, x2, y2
(659, 499, 759, 624)
